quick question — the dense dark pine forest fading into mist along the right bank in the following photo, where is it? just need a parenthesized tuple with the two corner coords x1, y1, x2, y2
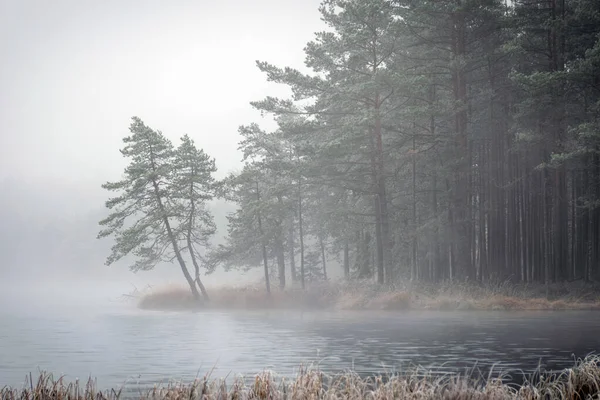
(99, 0, 600, 296)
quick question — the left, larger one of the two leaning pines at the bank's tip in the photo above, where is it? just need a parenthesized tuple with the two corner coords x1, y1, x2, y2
(98, 117, 201, 300)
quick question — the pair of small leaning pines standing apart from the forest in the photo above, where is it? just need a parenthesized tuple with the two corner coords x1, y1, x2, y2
(98, 117, 216, 300)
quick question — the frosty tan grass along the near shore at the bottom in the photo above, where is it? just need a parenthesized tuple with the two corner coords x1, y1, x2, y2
(0, 356, 600, 400)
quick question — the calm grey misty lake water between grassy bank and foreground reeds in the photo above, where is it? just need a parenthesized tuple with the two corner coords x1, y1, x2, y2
(0, 286, 600, 388)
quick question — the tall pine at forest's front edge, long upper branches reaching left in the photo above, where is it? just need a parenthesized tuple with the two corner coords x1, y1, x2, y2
(253, 0, 406, 283)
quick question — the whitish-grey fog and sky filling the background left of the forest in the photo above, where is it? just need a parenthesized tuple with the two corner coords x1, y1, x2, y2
(0, 0, 321, 290)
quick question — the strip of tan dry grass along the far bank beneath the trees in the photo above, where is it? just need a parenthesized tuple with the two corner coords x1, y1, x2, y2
(138, 282, 600, 310)
